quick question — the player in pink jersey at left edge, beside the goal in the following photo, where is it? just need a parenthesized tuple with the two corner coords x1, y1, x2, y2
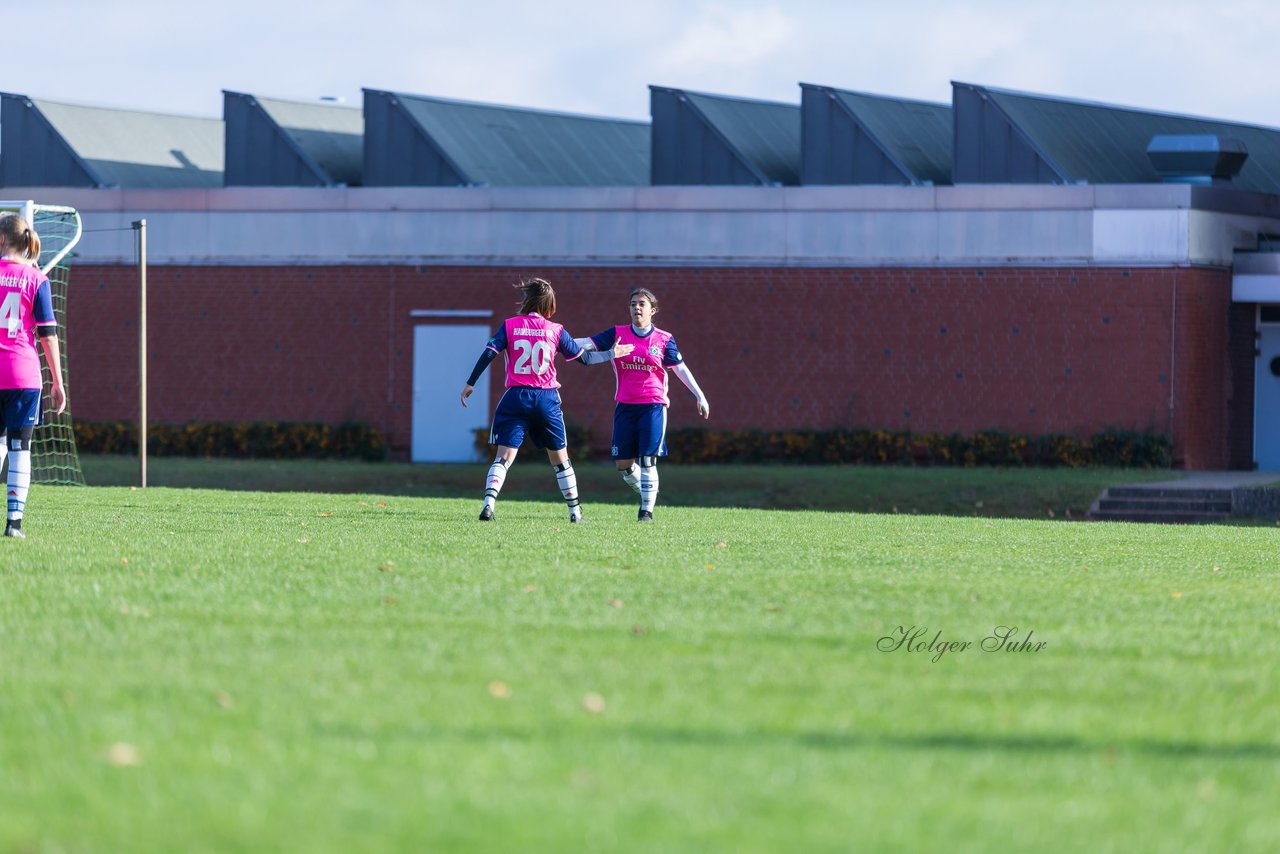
(0, 214, 67, 538)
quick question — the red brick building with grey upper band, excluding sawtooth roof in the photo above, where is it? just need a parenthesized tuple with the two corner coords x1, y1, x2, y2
(27, 184, 1280, 469)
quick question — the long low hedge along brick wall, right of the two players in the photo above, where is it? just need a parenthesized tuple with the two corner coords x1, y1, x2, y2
(667, 428, 1172, 469)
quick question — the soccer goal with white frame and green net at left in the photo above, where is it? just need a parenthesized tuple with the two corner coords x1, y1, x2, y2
(0, 201, 84, 485)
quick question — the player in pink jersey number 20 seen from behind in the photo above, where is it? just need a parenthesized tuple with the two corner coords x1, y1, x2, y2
(462, 279, 631, 522)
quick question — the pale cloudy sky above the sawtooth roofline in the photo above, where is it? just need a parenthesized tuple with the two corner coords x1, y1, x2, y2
(20, 0, 1280, 128)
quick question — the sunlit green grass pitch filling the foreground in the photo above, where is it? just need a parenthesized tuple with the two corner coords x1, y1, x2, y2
(0, 478, 1280, 851)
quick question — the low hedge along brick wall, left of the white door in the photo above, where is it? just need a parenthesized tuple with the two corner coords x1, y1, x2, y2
(74, 421, 387, 460)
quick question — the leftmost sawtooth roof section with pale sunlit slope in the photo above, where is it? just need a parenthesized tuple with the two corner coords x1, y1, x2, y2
(4, 95, 223, 188)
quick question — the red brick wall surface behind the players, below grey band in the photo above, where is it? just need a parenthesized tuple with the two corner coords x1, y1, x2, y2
(69, 266, 1252, 469)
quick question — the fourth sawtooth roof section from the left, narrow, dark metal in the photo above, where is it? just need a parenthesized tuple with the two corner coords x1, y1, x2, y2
(649, 86, 800, 186)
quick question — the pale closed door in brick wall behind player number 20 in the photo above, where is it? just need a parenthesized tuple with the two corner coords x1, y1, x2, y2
(410, 325, 488, 462)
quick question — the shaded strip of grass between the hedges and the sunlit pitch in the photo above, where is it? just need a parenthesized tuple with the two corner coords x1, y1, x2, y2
(81, 456, 1170, 520)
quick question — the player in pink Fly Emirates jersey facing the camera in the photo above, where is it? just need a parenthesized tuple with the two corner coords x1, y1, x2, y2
(577, 288, 712, 522)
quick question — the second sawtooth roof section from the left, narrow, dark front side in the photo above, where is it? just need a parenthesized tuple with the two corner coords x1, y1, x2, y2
(223, 90, 365, 187)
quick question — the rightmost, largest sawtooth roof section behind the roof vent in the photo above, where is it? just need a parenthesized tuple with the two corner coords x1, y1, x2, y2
(952, 82, 1280, 193)
